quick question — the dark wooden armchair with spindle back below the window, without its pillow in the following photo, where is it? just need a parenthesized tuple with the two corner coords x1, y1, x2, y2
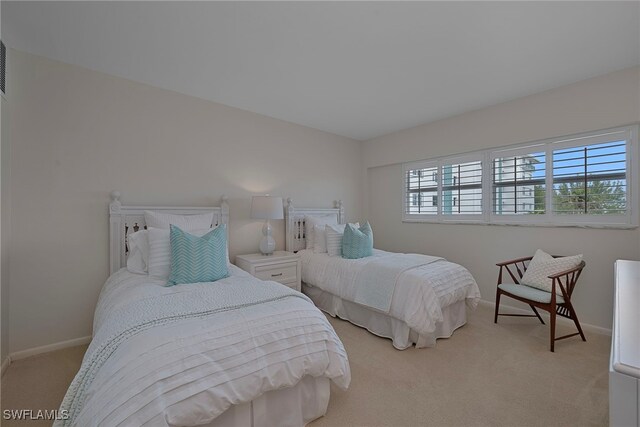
(493, 255, 587, 352)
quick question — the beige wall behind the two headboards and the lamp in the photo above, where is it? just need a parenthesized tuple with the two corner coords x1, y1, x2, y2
(9, 50, 362, 352)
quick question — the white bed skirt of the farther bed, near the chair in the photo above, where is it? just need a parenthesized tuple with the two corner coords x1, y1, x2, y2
(302, 283, 467, 350)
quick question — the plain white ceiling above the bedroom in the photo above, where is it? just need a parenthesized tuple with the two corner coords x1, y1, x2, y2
(2, 1, 640, 140)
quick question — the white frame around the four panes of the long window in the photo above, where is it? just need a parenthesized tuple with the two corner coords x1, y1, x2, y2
(402, 124, 640, 228)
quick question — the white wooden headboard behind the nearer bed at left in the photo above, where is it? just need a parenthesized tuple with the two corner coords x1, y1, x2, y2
(109, 191, 229, 274)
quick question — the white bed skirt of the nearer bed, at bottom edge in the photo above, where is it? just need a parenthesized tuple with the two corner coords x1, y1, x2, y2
(205, 376, 330, 427)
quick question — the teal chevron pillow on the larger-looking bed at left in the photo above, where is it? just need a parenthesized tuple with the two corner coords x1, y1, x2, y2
(167, 224, 229, 286)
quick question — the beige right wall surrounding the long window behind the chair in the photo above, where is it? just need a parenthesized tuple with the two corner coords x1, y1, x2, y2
(363, 67, 640, 329)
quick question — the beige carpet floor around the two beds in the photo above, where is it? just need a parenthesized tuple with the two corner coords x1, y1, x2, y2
(1, 306, 610, 427)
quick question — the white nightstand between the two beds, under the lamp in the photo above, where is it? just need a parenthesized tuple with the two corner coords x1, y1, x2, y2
(236, 251, 302, 291)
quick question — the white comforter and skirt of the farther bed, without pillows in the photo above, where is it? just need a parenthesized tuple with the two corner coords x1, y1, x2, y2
(298, 249, 480, 349)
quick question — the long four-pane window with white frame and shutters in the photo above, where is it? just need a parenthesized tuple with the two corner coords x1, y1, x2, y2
(403, 126, 639, 227)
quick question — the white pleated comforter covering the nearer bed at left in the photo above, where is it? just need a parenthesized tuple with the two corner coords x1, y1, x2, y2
(56, 266, 350, 427)
